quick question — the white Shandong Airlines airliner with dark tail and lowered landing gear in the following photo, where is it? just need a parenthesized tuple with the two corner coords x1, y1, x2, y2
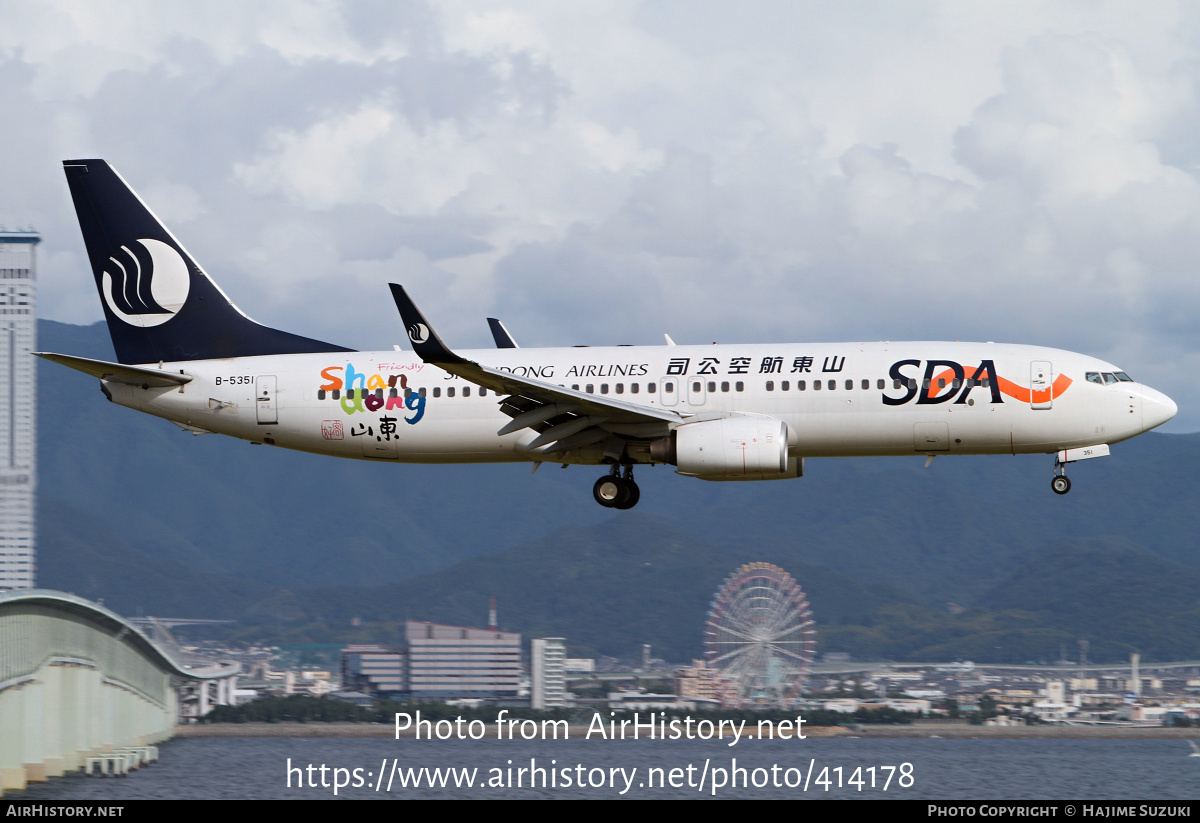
(37, 160, 1177, 509)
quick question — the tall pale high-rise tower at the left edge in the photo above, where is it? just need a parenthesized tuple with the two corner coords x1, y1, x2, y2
(0, 230, 41, 589)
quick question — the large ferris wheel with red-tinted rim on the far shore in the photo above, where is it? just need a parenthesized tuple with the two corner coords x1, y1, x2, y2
(704, 563, 817, 701)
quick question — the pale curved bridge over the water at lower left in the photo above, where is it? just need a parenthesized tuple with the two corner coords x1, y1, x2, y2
(0, 589, 240, 794)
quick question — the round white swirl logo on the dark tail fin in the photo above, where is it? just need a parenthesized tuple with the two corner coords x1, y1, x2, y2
(100, 239, 192, 329)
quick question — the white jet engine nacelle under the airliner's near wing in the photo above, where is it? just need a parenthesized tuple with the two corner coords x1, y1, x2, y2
(650, 414, 804, 480)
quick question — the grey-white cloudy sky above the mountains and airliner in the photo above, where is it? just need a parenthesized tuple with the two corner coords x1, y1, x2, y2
(7, 0, 1200, 432)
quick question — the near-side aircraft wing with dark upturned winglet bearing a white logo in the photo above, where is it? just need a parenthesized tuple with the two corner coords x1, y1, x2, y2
(390, 283, 684, 455)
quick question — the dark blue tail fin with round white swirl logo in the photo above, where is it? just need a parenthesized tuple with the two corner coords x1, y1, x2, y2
(62, 160, 353, 364)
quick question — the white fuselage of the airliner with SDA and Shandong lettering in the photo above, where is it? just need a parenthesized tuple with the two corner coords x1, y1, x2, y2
(104, 342, 1176, 463)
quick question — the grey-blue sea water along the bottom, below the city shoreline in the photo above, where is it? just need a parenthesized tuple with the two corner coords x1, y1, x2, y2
(5, 738, 1200, 800)
